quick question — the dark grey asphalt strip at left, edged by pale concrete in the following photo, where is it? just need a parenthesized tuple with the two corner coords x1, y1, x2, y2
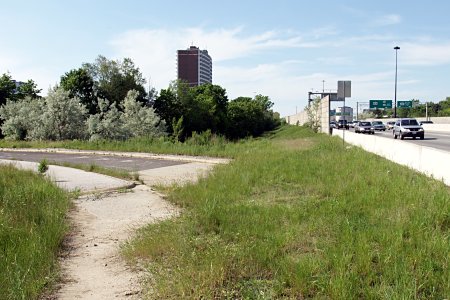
(0, 151, 186, 171)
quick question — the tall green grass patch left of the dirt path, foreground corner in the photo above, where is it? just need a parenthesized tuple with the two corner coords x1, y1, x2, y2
(0, 165, 70, 299)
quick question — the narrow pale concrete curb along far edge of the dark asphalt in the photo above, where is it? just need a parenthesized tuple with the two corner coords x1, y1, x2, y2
(0, 148, 231, 164)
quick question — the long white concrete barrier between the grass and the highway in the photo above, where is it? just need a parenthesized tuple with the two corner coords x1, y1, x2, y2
(333, 130, 450, 186)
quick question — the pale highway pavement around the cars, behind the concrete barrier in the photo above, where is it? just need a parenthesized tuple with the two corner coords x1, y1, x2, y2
(344, 128, 450, 152)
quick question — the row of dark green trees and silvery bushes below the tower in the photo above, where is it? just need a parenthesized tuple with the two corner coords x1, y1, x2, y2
(0, 56, 280, 141)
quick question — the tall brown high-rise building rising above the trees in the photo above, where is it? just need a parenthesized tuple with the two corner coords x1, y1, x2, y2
(177, 46, 212, 86)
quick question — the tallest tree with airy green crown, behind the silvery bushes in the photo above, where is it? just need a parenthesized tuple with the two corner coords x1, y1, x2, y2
(83, 55, 147, 108)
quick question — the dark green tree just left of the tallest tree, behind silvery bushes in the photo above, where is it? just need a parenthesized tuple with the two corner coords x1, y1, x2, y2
(60, 68, 98, 114)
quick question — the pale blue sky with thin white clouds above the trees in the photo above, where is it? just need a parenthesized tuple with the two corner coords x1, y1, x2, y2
(0, 0, 450, 116)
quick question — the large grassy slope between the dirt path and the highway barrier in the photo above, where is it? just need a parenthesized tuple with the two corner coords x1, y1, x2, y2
(124, 127, 450, 299)
